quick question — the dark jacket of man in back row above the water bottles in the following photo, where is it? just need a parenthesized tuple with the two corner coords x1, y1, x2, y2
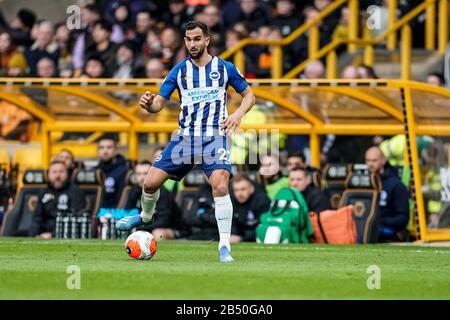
(96, 155, 128, 208)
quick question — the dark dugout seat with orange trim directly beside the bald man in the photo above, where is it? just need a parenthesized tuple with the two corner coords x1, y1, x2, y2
(339, 171, 381, 243)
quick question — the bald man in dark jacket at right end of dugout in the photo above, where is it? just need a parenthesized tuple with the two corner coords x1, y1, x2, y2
(365, 147, 409, 242)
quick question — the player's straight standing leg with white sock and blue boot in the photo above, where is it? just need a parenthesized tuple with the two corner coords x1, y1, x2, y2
(209, 169, 233, 262)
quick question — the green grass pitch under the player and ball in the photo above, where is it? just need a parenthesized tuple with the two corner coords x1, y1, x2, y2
(0, 238, 450, 299)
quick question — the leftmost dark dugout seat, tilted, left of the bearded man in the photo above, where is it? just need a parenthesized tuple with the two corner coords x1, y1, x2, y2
(1, 169, 47, 236)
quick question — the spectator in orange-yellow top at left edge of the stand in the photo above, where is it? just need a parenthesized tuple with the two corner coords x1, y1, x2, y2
(0, 31, 27, 76)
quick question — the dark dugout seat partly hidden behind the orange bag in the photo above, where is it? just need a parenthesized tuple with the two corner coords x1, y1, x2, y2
(323, 164, 351, 209)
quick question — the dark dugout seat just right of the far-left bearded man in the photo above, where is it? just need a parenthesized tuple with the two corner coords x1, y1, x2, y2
(73, 169, 104, 218)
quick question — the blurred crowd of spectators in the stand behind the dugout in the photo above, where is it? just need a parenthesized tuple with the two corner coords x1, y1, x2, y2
(0, 0, 442, 79)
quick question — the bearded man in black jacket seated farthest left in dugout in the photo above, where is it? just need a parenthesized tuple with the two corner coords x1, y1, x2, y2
(29, 161, 85, 239)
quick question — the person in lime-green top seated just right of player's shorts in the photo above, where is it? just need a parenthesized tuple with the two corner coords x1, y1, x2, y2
(259, 155, 288, 200)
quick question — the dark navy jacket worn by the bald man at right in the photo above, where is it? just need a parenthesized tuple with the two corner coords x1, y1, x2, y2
(379, 163, 409, 231)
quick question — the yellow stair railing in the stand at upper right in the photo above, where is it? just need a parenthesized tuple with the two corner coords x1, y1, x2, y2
(221, 0, 449, 80)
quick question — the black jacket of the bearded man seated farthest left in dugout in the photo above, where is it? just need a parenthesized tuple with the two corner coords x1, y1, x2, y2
(30, 181, 85, 237)
